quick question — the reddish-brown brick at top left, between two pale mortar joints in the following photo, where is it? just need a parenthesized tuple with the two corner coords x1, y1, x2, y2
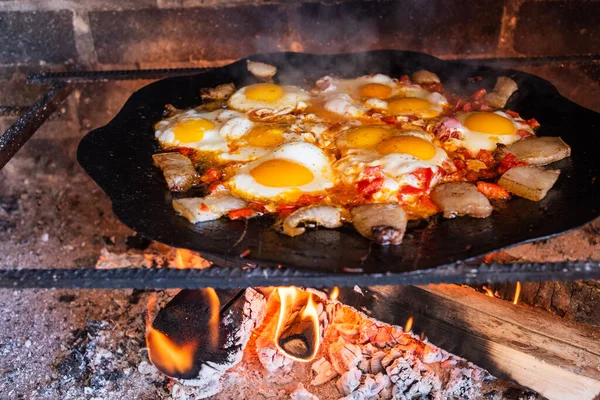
(90, 5, 287, 64)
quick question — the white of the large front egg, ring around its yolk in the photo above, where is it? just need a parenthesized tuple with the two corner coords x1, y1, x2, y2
(227, 142, 334, 201)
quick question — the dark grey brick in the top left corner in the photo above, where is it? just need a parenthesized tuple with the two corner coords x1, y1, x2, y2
(0, 11, 77, 64)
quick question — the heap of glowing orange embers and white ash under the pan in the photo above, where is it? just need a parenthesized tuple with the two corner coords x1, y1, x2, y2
(146, 289, 541, 400)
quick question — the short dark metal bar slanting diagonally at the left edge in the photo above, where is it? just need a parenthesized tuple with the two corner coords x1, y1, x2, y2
(0, 82, 73, 169)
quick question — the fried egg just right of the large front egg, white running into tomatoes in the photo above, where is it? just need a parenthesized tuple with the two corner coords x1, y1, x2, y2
(333, 132, 448, 201)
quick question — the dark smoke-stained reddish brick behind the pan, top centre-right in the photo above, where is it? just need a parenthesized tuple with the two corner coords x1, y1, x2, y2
(292, 0, 502, 55)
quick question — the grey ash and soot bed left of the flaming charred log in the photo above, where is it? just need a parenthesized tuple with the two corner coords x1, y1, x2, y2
(0, 290, 171, 400)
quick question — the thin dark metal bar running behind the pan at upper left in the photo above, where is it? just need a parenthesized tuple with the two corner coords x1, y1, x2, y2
(27, 68, 213, 84)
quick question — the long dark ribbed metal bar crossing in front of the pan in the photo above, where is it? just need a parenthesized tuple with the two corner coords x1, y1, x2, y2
(0, 261, 600, 289)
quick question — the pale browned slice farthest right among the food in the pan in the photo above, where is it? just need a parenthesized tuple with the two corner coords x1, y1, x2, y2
(495, 136, 571, 165)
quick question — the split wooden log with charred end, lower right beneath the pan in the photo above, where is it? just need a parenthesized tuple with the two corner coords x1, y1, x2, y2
(350, 285, 600, 400)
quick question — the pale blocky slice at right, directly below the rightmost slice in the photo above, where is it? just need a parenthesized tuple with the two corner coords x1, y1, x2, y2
(498, 166, 560, 201)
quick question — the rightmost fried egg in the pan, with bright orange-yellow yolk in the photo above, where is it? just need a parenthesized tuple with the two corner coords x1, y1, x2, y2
(435, 111, 533, 154)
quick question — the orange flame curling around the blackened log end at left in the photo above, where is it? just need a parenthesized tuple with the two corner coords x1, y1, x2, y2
(146, 288, 221, 376)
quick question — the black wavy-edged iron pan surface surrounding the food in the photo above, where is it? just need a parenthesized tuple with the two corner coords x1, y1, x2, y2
(78, 51, 600, 284)
